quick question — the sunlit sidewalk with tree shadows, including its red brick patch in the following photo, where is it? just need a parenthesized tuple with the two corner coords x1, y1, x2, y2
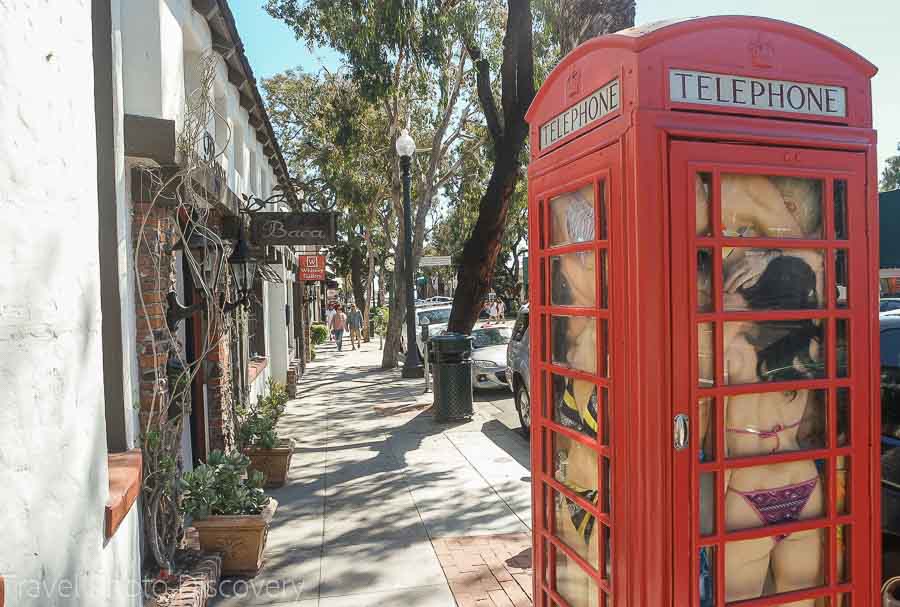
(215, 342, 531, 607)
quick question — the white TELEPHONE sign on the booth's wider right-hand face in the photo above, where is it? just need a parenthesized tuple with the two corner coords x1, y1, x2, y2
(669, 69, 847, 118)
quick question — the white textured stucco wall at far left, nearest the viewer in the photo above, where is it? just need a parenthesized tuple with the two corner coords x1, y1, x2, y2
(0, 0, 140, 607)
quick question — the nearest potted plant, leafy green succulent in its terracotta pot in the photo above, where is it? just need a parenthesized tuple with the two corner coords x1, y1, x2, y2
(181, 451, 278, 576)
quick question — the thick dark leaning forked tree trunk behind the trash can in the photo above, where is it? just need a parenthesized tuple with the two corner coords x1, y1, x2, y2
(448, 0, 535, 333)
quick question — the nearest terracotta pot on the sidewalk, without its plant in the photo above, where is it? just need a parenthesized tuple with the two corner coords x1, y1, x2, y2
(194, 498, 278, 576)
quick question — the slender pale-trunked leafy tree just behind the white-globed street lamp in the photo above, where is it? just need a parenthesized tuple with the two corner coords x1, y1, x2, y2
(266, 0, 477, 368)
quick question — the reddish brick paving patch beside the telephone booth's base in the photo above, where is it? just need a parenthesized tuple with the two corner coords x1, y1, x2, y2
(432, 533, 533, 607)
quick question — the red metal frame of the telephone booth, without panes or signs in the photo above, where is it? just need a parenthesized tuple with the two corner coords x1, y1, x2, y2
(528, 17, 881, 607)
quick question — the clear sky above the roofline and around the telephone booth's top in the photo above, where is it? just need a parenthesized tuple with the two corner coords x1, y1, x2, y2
(230, 0, 900, 171)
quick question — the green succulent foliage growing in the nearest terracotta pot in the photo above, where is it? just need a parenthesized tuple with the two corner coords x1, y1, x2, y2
(181, 451, 269, 518)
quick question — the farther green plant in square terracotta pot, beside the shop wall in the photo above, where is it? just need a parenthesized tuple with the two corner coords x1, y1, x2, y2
(237, 379, 294, 488)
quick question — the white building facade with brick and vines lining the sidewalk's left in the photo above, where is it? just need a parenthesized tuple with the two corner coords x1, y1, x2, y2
(0, 0, 310, 607)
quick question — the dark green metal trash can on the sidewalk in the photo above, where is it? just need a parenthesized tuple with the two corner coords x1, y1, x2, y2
(430, 333, 474, 422)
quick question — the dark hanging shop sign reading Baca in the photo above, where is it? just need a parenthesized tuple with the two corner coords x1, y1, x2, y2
(250, 213, 337, 245)
